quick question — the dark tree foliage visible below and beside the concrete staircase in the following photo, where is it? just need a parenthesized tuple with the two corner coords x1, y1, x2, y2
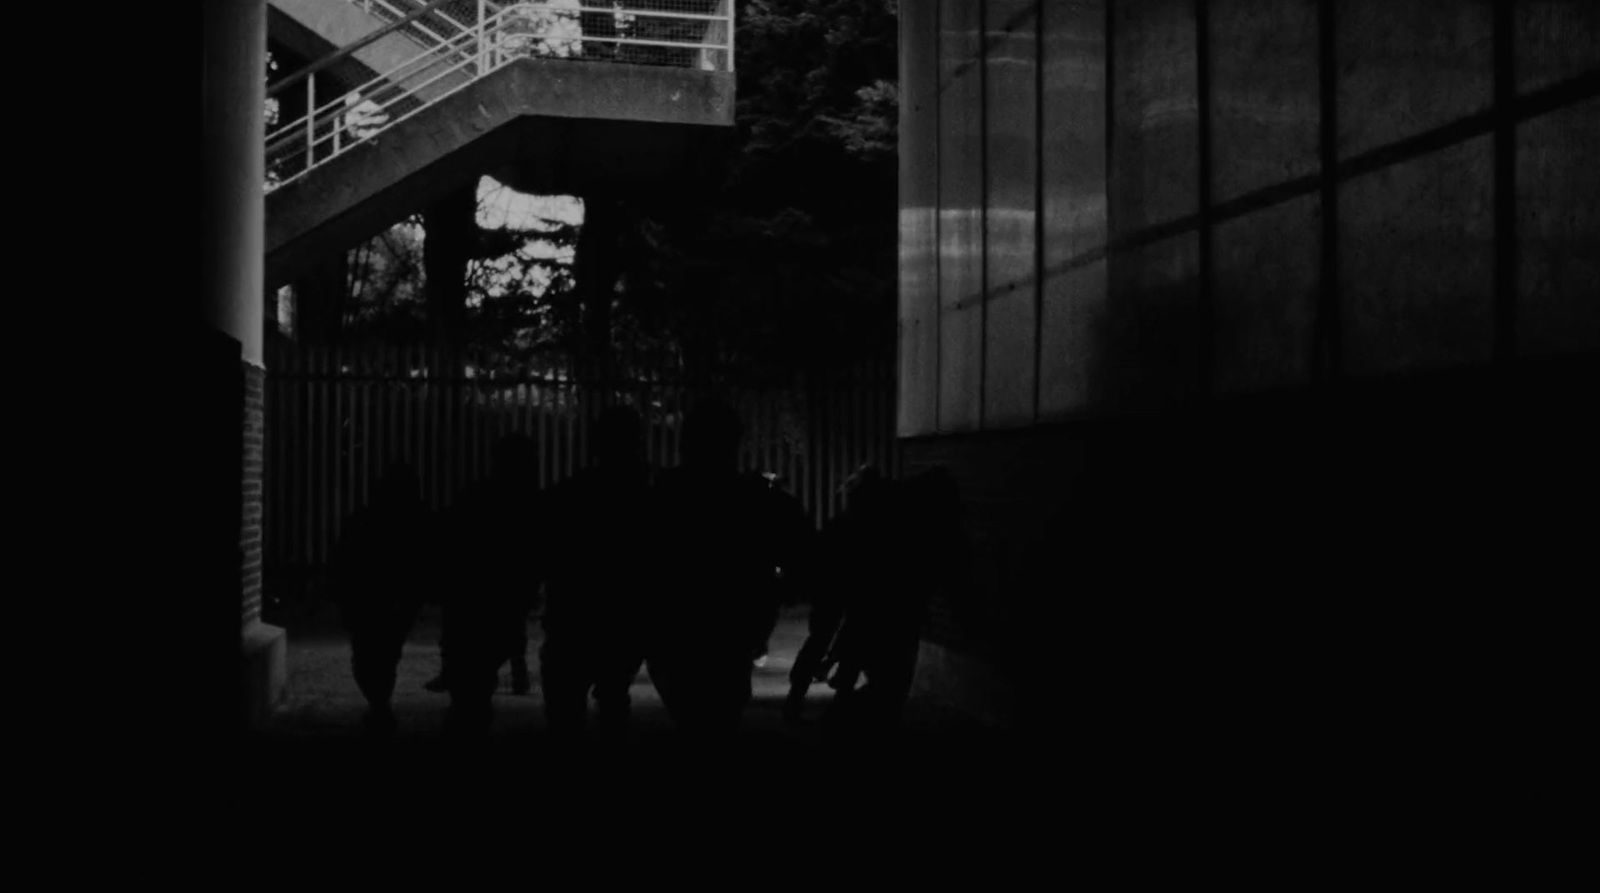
(310, 0, 898, 376)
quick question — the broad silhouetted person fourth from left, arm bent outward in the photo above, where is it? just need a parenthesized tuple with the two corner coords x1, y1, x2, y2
(650, 402, 810, 736)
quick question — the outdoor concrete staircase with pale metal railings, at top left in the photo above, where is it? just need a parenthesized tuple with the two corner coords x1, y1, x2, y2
(266, 0, 734, 290)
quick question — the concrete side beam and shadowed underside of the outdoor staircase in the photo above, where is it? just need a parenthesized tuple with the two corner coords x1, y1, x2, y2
(267, 59, 733, 288)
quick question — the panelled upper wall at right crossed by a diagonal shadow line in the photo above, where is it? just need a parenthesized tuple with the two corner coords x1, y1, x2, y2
(901, 0, 1600, 437)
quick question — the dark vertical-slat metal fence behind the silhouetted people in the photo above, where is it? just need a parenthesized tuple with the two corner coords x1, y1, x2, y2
(262, 342, 899, 603)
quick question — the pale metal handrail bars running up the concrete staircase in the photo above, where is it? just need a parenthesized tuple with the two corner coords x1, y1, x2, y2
(266, 0, 734, 189)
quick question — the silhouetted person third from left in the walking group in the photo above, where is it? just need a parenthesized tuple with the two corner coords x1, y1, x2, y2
(539, 406, 651, 733)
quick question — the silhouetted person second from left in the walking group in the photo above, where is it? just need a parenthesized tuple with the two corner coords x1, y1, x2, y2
(440, 435, 541, 731)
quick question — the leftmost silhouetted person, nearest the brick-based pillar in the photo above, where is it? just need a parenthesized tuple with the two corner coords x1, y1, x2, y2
(333, 464, 434, 731)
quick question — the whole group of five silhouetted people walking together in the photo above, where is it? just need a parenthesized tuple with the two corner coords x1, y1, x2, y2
(324, 400, 958, 738)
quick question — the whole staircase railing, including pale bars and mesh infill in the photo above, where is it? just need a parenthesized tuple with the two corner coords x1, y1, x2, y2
(266, 0, 733, 189)
